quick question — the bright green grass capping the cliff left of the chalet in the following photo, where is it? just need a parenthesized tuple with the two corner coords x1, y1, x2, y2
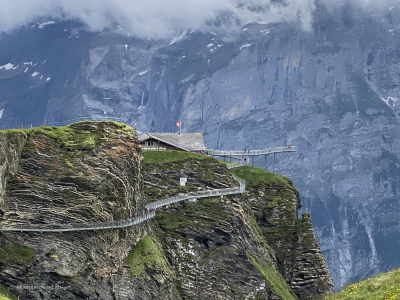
(0, 121, 134, 151)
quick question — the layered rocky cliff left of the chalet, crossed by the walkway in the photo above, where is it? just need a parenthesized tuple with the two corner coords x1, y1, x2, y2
(0, 122, 176, 299)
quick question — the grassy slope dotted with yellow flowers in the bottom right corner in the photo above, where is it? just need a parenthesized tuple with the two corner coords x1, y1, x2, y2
(325, 269, 400, 300)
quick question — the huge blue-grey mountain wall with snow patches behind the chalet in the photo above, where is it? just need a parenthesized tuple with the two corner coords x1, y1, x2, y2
(0, 1, 400, 288)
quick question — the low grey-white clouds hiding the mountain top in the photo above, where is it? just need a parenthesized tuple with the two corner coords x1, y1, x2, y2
(0, 0, 399, 38)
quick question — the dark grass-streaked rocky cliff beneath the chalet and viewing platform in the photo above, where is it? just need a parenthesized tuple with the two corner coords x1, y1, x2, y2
(144, 153, 333, 299)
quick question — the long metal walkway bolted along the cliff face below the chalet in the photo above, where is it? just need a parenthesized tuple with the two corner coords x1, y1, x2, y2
(0, 173, 246, 233)
